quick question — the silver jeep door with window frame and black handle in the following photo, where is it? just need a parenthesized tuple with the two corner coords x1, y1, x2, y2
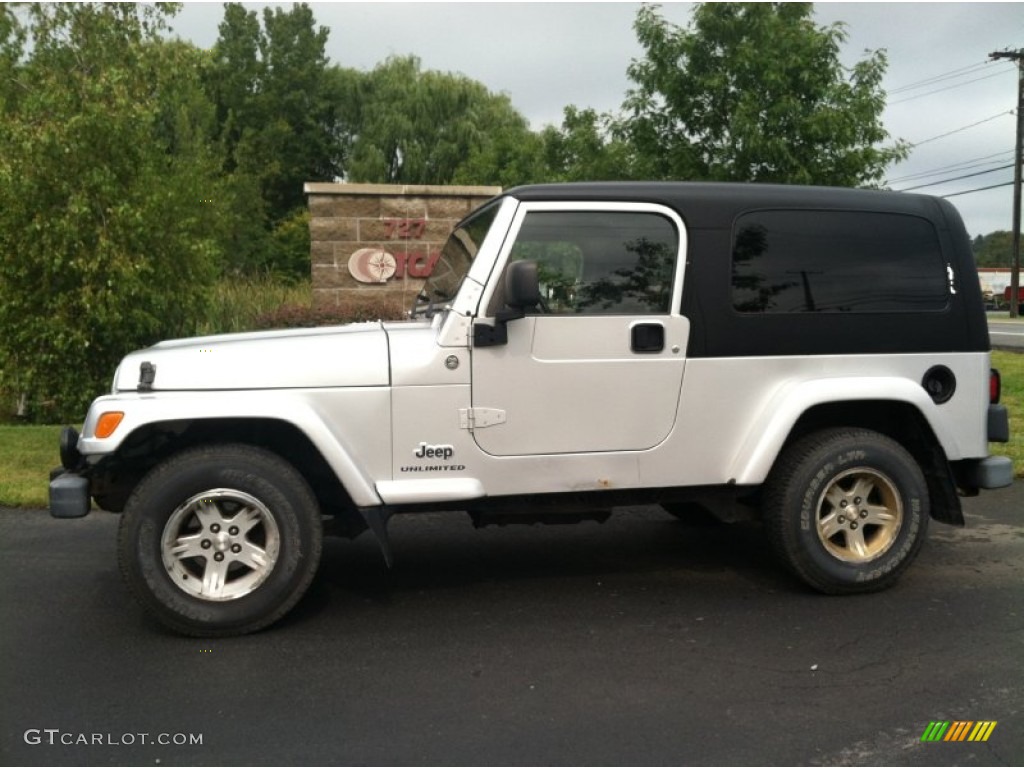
(472, 203, 689, 456)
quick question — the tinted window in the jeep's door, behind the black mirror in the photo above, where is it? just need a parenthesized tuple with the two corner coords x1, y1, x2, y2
(510, 211, 679, 314)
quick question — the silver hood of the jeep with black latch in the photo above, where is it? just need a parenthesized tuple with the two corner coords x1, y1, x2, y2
(114, 323, 390, 391)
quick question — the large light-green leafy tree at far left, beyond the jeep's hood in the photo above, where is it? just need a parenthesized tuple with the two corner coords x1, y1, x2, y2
(0, 4, 221, 419)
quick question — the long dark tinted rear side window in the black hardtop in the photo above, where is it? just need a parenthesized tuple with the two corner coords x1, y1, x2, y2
(732, 211, 949, 312)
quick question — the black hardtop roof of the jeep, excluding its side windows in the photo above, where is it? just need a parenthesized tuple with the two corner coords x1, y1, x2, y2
(505, 181, 989, 357)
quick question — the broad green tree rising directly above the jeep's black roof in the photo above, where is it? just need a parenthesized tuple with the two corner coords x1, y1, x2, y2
(618, 3, 907, 186)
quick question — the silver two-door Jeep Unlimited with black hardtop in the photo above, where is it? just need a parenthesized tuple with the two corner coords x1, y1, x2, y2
(50, 183, 1013, 636)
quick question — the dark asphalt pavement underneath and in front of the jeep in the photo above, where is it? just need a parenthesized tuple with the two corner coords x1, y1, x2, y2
(0, 482, 1024, 766)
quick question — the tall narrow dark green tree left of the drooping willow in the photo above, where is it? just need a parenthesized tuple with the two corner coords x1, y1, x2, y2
(206, 3, 335, 276)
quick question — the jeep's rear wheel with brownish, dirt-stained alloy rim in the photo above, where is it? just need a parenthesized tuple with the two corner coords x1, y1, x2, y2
(764, 429, 929, 594)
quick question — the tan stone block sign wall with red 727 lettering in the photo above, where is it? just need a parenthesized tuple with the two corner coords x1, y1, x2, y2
(305, 182, 502, 309)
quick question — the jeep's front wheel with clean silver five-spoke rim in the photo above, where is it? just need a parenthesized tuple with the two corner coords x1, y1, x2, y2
(118, 445, 323, 637)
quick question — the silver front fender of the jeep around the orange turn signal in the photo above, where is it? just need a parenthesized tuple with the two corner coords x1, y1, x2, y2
(78, 387, 391, 507)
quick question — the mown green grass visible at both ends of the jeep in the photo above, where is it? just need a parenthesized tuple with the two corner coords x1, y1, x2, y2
(0, 351, 1024, 507)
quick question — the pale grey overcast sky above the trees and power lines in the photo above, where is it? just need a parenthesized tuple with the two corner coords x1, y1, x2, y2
(172, 2, 1024, 236)
